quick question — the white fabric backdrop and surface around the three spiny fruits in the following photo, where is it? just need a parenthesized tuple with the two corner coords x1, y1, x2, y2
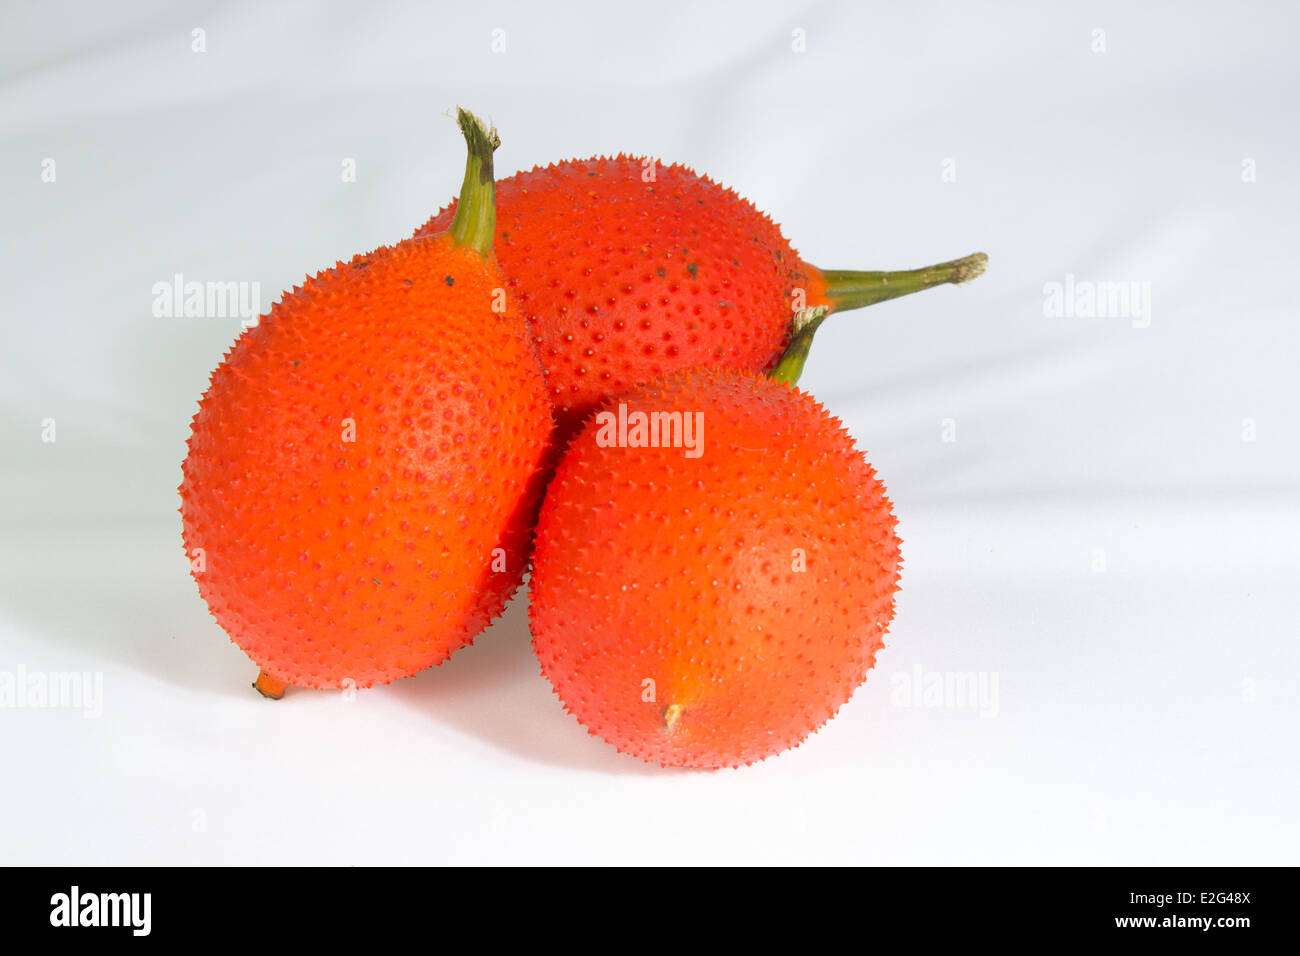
(0, 3, 1300, 864)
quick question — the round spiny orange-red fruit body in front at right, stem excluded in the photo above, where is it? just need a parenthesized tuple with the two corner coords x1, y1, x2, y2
(529, 369, 901, 767)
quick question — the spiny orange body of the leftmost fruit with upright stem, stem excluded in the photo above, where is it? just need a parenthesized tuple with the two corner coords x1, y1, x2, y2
(181, 235, 551, 688)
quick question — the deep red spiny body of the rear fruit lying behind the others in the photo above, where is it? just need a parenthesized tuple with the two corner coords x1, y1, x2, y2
(416, 155, 828, 437)
